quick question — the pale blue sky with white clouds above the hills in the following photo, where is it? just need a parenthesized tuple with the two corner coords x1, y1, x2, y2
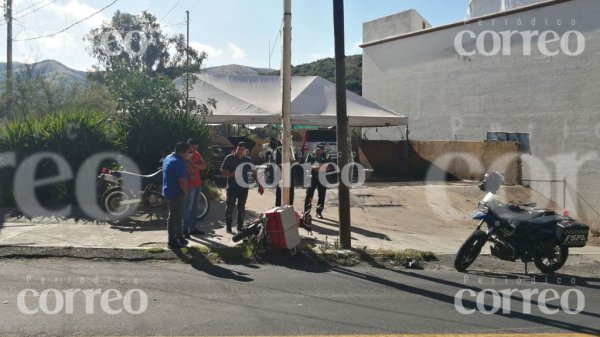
(0, 0, 468, 70)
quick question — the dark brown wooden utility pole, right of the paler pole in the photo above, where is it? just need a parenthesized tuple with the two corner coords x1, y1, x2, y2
(333, 0, 352, 249)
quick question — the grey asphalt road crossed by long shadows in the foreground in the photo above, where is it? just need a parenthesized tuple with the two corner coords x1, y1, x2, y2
(0, 259, 600, 336)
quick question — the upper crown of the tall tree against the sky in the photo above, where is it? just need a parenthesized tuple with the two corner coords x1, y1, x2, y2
(84, 11, 206, 79)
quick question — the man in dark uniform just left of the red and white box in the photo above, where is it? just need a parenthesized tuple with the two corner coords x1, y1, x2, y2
(221, 142, 264, 234)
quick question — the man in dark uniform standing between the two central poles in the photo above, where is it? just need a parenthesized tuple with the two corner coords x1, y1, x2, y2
(304, 143, 331, 219)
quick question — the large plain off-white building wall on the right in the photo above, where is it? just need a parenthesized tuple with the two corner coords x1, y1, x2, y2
(363, 0, 600, 224)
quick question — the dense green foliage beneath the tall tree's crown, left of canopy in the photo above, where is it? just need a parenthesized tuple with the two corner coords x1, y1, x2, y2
(107, 71, 216, 172)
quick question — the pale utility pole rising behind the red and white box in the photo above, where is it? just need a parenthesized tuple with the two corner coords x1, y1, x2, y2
(281, 0, 292, 205)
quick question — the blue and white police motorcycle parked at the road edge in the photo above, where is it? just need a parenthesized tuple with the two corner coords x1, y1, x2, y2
(454, 171, 589, 274)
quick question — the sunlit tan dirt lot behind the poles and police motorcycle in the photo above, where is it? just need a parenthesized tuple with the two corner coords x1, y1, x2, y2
(241, 182, 600, 253)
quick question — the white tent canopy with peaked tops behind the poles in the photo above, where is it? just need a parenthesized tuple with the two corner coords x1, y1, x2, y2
(176, 74, 407, 126)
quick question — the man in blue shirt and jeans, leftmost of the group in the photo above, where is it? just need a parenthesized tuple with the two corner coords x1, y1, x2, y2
(163, 142, 192, 249)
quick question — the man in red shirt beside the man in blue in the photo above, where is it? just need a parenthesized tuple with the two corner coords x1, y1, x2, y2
(183, 138, 206, 239)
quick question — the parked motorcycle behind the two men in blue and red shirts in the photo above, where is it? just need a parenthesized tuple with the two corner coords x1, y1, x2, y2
(97, 168, 210, 220)
